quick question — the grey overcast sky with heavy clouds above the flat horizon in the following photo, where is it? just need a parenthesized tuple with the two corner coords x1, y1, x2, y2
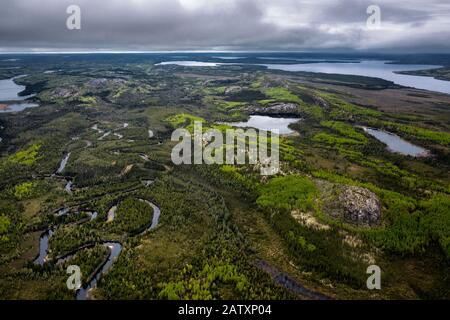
(0, 0, 450, 53)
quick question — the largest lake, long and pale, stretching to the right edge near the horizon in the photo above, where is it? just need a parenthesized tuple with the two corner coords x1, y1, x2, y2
(262, 61, 450, 94)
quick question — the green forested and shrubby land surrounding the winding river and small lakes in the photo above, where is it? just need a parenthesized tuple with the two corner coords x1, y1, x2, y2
(0, 55, 450, 300)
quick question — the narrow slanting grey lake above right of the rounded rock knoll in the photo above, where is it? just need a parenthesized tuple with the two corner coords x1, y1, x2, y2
(362, 127, 428, 157)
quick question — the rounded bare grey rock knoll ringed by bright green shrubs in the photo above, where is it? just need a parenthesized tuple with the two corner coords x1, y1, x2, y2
(338, 186, 381, 226)
